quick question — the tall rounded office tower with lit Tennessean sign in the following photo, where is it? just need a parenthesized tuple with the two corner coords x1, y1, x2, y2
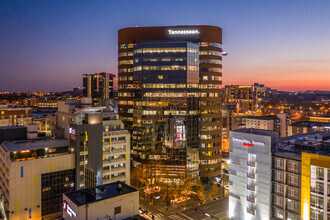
(118, 25, 222, 184)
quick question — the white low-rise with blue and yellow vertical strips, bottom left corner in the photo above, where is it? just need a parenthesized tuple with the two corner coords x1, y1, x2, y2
(0, 135, 75, 220)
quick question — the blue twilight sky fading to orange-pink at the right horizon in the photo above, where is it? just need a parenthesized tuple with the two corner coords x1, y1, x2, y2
(0, 0, 330, 91)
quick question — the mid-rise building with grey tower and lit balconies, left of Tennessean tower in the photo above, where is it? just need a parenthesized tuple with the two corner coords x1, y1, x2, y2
(69, 110, 130, 189)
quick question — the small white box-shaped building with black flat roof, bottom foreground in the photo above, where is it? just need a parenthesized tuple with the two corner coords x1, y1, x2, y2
(62, 181, 139, 220)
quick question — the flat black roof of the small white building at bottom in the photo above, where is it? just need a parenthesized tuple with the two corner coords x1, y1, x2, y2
(64, 181, 137, 206)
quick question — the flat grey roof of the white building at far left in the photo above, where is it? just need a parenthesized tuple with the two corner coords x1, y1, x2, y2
(2, 138, 69, 152)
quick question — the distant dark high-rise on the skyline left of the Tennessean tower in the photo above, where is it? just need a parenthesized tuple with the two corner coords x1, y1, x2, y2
(83, 72, 116, 101)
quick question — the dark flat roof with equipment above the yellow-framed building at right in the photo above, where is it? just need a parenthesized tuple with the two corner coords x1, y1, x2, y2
(274, 131, 330, 159)
